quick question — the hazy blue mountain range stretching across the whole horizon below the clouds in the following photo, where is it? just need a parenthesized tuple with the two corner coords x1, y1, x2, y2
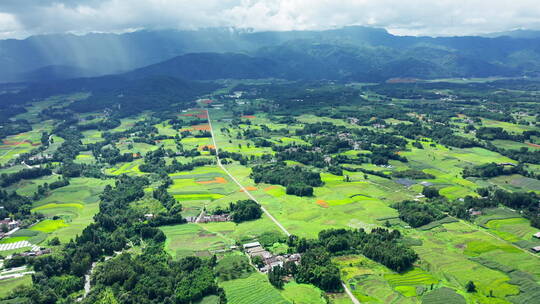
(0, 27, 540, 82)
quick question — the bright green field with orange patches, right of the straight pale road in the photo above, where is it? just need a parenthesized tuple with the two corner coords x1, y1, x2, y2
(219, 165, 397, 237)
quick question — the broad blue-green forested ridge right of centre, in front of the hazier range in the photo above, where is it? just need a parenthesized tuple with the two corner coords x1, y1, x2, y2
(127, 41, 520, 82)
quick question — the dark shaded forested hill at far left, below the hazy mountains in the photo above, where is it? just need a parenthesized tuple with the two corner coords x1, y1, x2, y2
(0, 76, 219, 119)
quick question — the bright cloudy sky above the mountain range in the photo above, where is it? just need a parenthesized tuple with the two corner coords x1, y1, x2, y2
(0, 0, 540, 39)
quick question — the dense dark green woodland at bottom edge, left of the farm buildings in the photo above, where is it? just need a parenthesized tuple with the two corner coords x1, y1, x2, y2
(84, 245, 222, 304)
